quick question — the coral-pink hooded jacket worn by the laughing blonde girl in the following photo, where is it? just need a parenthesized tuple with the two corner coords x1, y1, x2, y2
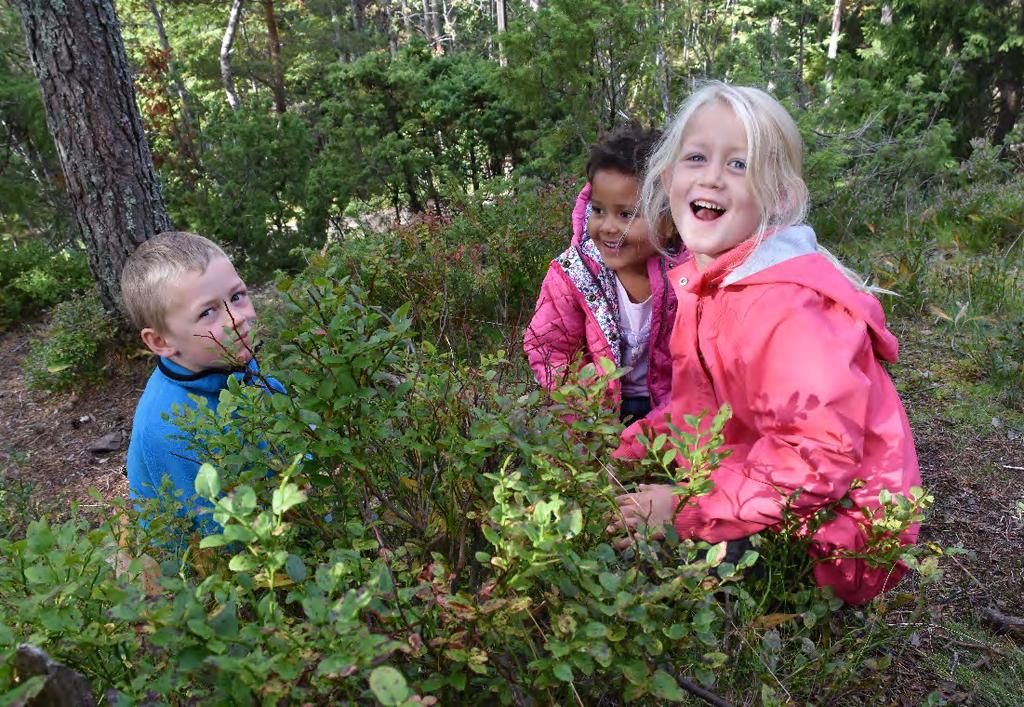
(616, 226, 921, 604)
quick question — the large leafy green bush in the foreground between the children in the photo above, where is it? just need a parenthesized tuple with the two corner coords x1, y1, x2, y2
(0, 262, 931, 705)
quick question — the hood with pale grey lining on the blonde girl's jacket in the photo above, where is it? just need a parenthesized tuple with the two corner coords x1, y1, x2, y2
(720, 224, 899, 363)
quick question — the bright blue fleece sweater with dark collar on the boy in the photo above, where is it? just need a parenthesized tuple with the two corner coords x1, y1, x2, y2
(127, 358, 280, 532)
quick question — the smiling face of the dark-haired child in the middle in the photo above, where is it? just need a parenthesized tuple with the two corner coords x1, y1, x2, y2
(589, 169, 657, 274)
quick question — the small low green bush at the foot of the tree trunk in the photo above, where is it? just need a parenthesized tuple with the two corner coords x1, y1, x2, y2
(25, 293, 117, 390)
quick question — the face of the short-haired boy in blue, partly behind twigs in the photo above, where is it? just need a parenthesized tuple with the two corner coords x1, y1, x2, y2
(148, 255, 256, 371)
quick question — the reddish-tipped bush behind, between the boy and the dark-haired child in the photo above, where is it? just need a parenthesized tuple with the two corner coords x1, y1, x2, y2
(311, 179, 580, 354)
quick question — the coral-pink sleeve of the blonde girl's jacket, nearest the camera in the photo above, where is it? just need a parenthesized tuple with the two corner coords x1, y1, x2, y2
(676, 288, 873, 542)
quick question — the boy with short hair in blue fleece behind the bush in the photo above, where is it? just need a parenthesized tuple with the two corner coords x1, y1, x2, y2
(121, 232, 272, 528)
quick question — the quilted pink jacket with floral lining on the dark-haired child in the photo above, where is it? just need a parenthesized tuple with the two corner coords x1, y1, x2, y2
(523, 184, 682, 415)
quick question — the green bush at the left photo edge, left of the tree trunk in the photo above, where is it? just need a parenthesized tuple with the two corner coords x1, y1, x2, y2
(0, 238, 92, 331)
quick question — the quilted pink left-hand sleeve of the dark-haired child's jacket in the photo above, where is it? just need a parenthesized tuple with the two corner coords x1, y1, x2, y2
(523, 263, 587, 390)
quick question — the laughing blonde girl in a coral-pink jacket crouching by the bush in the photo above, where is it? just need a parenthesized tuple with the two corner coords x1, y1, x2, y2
(612, 82, 920, 602)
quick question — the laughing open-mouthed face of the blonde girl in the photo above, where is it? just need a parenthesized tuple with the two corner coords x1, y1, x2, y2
(662, 100, 761, 271)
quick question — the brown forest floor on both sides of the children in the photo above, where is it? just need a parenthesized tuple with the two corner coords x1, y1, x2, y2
(0, 311, 1024, 705)
